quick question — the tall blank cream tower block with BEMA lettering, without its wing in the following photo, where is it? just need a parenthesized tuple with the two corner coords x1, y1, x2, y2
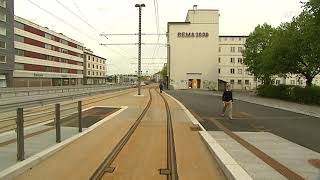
(167, 9, 219, 89)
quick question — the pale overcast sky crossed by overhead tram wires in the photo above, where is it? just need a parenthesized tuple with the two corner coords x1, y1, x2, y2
(15, 0, 301, 74)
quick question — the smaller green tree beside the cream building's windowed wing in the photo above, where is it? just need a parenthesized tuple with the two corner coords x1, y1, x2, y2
(243, 24, 275, 84)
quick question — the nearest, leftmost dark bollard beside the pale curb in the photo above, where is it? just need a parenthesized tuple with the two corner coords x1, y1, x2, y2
(16, 108, 24, 161)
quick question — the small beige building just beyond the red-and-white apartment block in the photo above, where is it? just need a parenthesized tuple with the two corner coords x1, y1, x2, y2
(84, 49, 107, 85)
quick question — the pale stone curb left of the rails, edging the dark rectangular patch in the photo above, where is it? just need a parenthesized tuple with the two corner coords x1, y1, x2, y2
(0, 106, 128, 179)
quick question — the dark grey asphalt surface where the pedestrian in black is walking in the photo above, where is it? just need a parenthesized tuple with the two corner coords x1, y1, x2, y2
(166, 90, 320, 153)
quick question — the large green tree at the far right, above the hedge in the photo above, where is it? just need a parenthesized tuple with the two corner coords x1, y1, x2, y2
(271, 1, 320, 86)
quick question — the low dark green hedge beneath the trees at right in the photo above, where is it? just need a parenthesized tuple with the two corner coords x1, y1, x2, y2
(257, 84, 320, 105)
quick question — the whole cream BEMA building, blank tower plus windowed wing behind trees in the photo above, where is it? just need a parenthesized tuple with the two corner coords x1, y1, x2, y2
(167, 8, 320, 90)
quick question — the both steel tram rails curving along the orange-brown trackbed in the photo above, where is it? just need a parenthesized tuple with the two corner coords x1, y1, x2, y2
(90, 88, 178, 180)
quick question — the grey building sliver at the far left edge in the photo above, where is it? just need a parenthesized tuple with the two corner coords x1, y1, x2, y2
(0, 0, 14, 88)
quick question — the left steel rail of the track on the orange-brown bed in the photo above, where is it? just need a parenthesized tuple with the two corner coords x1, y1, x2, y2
(90, 88, 152, 180)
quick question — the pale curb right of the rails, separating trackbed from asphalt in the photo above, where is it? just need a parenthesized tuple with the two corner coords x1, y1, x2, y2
(165, 93, 252, 180)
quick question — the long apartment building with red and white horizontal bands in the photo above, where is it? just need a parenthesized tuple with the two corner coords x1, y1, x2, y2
(13, 16, 84, 87)
